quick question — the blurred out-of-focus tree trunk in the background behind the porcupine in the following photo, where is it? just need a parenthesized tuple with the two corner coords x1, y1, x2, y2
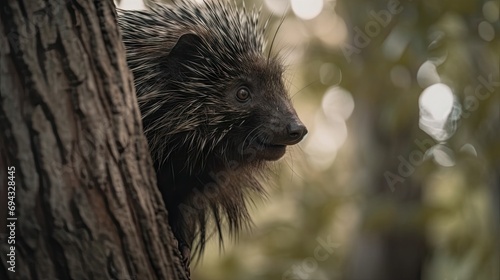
(337, 0, 432, 280)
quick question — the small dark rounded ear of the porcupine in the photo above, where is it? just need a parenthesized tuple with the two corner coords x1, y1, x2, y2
(165, 33, 202, 76)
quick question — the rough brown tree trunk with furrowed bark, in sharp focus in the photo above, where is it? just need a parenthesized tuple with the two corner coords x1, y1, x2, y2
(0, 0, 188, 279)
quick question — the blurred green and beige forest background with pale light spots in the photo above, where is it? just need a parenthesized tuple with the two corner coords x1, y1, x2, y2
(120, 0, 500, 280)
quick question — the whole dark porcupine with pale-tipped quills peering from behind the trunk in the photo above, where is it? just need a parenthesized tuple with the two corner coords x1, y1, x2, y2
(118, 0, 307, 262)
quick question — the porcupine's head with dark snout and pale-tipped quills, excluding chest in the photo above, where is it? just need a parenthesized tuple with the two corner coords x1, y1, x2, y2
(120, 1, 307, 174)
